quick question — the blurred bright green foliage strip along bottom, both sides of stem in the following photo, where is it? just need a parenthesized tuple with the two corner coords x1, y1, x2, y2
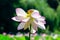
(0, 34, 60, 40)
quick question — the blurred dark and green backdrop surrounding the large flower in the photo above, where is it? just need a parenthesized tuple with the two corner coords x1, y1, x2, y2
(0, 0, 60, 34)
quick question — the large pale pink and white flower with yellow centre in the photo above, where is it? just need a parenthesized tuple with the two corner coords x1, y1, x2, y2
(12, 8, 46, 30)
